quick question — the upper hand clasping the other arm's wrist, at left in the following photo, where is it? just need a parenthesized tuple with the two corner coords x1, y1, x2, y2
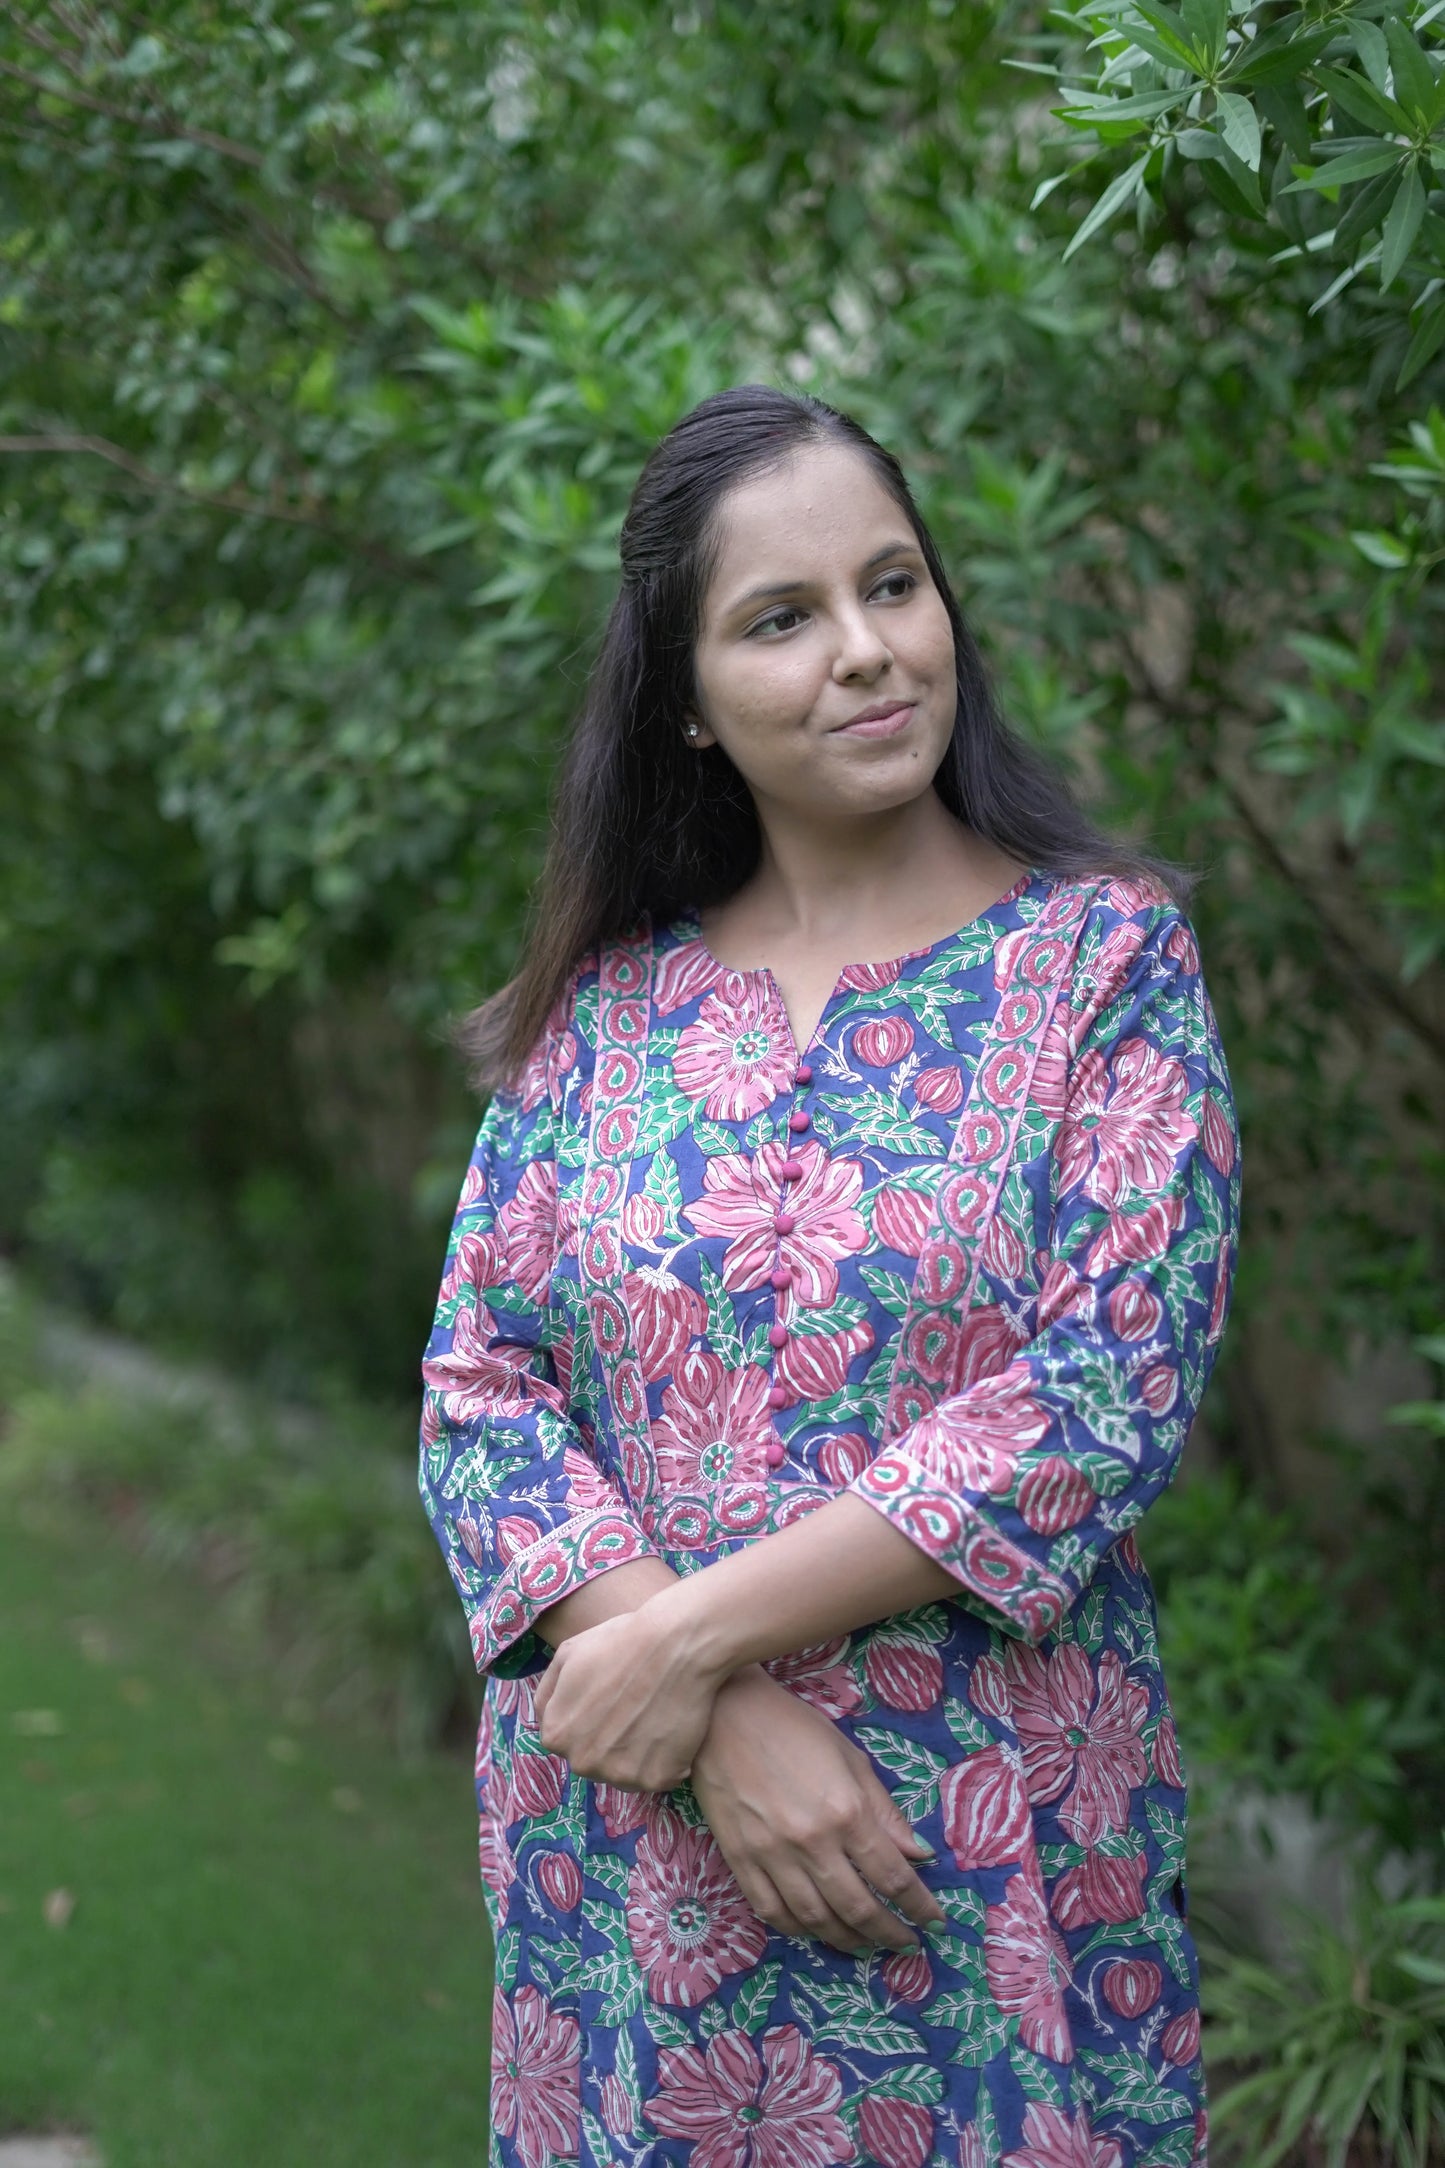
(537, 1604, 719, 1791)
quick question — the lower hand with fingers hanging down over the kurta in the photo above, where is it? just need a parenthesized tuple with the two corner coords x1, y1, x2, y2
(693, 1669, 947, 1956)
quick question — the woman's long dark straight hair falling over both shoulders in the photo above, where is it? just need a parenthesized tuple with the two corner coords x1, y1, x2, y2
(459, 384, 1187, 1086)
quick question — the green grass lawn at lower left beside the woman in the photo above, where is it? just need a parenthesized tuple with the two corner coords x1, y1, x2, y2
(0, 1509, 490, 2168)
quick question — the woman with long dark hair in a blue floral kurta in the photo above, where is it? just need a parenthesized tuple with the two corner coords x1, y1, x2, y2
(422, 386, 1237, 2168)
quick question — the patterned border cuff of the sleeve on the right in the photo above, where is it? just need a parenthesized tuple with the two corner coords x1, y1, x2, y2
(849, 1446, 1075, 1641)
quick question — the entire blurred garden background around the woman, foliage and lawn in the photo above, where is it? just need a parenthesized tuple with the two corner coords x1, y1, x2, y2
(0, 0, 1445, 2168)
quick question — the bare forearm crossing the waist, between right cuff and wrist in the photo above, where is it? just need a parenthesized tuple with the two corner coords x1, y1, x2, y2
(645, 1496, 958, 1678)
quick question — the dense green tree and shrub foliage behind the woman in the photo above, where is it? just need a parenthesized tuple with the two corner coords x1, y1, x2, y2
(0, 0, 1445, 2159)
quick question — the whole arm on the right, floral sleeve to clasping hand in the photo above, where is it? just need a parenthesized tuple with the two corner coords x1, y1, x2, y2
(542, 908, 1237, 1756)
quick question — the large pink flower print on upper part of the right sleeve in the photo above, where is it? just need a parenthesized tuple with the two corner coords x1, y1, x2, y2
(1053, 1038, 1196, 1205)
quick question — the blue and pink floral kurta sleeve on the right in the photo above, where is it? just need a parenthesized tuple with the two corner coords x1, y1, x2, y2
(851, 906, 1239, 1641)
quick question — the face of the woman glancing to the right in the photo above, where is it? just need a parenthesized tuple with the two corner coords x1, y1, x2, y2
(689, 442, 958, 820)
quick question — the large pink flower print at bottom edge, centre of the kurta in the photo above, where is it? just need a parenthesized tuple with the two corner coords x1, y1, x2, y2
(645, 2025, 858, 2168)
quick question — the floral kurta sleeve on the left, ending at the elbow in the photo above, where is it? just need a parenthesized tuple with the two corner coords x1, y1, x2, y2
(420, 1070, 654, 1674)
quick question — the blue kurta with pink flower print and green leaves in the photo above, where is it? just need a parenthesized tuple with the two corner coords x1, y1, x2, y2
(422, 872, 1239, 2168)
